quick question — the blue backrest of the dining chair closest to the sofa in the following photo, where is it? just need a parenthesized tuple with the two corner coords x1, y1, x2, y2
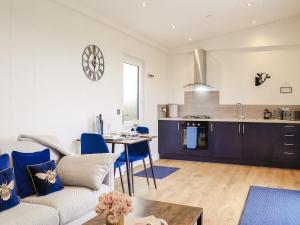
(81, 133, 109, 155)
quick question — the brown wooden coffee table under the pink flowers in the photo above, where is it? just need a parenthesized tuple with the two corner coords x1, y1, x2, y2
(84, 198, 203, 225)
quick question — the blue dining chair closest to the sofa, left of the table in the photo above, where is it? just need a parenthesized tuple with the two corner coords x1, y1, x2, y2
(81, 133, 125, 193)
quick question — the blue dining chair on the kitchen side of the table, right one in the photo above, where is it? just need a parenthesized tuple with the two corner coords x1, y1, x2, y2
(119, 127, 157, 193)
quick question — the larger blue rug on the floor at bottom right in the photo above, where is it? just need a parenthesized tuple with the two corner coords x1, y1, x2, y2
(239, 186, 300, 225)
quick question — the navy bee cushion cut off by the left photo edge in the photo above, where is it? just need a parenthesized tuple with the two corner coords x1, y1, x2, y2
(0, 168, 20, 212)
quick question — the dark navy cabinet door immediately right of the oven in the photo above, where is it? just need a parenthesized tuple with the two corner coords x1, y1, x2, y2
(209, 122, 242, 159)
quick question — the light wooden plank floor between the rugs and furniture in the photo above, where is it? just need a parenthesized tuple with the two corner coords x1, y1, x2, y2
(116, 160, 300, 225)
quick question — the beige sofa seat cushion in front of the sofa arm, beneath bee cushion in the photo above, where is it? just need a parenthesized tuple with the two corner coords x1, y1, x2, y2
(22, 185, 110, 225)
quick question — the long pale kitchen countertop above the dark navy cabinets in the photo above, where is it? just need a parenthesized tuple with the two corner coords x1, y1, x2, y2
(158, 117, 300, 124)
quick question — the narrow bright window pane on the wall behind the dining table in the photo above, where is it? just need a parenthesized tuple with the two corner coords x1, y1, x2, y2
(123, 63, 140, 123)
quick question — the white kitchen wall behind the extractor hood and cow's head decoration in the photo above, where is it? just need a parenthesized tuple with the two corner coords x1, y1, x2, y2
(168, 16, 300, 105)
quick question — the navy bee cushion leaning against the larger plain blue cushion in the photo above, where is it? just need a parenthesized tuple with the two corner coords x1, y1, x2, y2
(27, 160, 64, 196)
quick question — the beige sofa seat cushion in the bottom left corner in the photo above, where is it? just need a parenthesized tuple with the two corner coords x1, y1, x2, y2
(0, 202, 59, 225)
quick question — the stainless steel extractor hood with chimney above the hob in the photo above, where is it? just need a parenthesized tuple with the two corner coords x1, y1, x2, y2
(184, 49, 212, 90)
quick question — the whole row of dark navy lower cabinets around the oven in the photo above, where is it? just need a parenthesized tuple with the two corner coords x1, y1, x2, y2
(158, 120, 300, 168)
